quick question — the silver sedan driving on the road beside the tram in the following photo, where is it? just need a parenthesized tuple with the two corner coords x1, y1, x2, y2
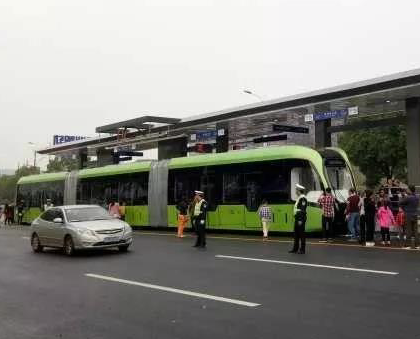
(31, 205, 133, 255)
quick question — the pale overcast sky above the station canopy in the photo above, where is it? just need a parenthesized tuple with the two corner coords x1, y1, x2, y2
(0, 0, 420, 168)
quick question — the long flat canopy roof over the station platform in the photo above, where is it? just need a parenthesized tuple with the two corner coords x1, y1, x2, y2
(39, 69, 420, 162)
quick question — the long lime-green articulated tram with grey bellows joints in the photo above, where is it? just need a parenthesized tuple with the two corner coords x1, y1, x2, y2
(17, 146, 354, 232)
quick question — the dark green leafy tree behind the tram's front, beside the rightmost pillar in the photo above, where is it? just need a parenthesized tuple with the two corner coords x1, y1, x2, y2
(339, 126, 407, 187)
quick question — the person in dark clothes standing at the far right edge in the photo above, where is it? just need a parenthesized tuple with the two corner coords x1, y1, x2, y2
(400, 185, 419, 249)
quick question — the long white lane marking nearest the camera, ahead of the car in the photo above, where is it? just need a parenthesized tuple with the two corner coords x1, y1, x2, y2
(85, 273, 261, 307)
